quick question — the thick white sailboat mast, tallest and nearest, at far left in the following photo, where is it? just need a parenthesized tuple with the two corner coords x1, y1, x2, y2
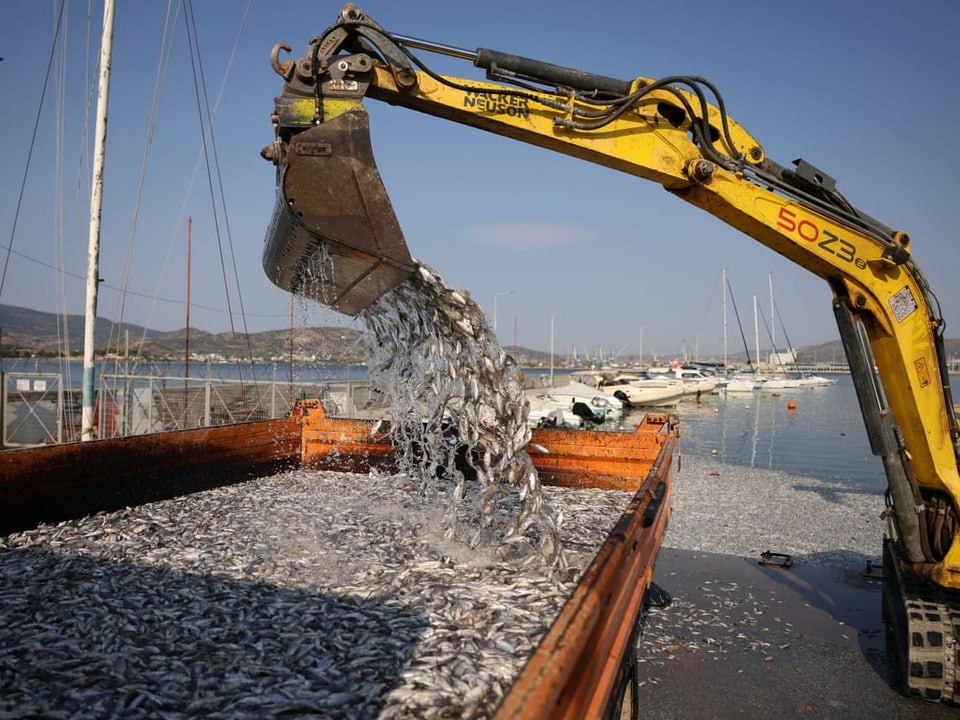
(80, 0, 114, 440)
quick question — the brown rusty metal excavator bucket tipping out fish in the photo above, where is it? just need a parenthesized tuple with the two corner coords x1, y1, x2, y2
(263, 110, 416, 315)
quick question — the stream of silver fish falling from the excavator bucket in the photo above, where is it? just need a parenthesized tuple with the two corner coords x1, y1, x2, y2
(360, 265, 563, 566)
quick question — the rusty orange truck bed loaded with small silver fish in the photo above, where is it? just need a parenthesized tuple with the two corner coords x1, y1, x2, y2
(0, 400, 678, 718)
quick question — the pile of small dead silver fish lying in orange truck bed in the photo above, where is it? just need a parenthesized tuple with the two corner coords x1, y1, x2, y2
(0, 471, 630, 718)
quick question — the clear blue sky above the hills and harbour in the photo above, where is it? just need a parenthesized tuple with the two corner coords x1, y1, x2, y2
(0, 0, 960, 358)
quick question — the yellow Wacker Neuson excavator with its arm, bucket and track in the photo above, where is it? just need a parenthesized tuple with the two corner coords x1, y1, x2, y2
(262, 4, 960, 703)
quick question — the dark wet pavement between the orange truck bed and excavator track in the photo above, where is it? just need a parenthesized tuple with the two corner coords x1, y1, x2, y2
(639, 548, 960, 720)
